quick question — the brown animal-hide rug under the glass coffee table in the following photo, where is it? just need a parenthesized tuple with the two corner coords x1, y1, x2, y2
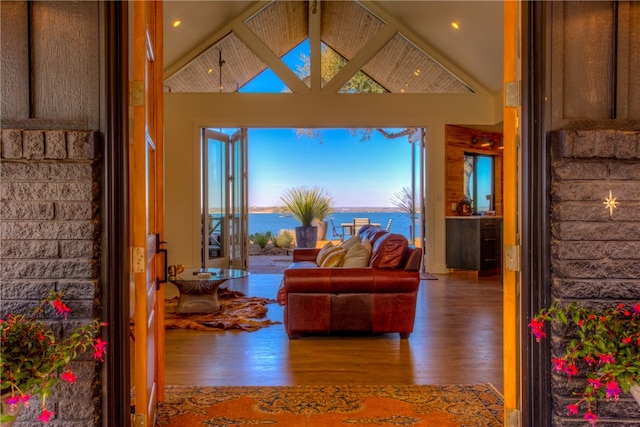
(164, 288, 281, 332)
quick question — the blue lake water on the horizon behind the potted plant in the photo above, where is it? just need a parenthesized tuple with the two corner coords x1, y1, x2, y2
(249, 212, 419, 239)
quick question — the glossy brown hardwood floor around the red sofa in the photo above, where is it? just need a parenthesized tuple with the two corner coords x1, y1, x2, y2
(165, 272, 504, 391)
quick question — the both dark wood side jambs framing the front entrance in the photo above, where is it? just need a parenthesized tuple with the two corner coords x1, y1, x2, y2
(102, 1, 551, 426)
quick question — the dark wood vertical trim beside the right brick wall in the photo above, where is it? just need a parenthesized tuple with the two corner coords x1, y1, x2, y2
(520, 1, 552, 427)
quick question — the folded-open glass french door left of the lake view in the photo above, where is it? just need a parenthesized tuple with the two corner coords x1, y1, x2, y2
(201, 129, 249, 270)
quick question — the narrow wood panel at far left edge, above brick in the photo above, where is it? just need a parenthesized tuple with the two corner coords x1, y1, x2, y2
(0, 1, 29, 121)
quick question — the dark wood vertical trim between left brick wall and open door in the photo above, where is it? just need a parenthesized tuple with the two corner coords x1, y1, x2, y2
(102, 1, 131, 427)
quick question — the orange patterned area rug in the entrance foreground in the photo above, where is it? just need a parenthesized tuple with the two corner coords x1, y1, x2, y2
(158, 384, 503, 427)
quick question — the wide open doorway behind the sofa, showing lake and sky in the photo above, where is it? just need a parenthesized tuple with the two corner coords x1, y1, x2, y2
(199, 128, 426, 269)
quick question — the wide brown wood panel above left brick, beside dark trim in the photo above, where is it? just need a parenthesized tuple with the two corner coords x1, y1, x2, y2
(30, 2, 100, 129)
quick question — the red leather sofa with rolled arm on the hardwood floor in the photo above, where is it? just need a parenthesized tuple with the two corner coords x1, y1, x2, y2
(278, 226, 422, 339)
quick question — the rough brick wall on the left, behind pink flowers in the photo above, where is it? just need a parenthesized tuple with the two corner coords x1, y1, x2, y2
(0, 129, 100, 427)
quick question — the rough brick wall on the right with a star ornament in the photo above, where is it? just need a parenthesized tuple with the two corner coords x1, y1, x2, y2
(549, 130, 640, 426)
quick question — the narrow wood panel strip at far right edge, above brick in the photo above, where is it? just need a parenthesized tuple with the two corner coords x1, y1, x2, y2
(618, 1, 640, 120)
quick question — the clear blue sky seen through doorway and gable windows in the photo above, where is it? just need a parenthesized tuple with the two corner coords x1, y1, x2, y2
(241, 42, 411, 207)
